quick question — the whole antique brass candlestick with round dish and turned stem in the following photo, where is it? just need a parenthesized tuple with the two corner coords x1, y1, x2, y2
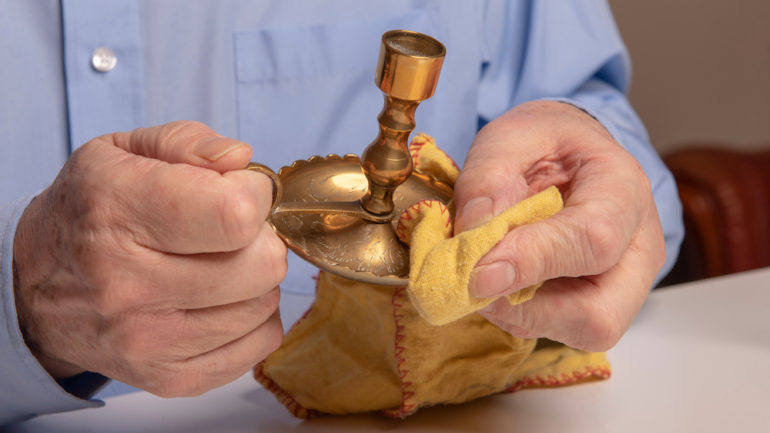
(248, 30, 452, 286)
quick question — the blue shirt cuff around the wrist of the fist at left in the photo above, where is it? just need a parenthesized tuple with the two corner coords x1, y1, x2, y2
(0, 197, 107, 425)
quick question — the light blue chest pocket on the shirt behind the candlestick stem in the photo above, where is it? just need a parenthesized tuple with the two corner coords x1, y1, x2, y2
(234, 9, 441, 170)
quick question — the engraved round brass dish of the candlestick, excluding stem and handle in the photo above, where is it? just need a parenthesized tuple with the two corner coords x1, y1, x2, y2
(270, 155, 452, 285)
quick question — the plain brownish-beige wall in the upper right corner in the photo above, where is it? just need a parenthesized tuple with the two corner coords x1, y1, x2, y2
(610, 0, 770, 154)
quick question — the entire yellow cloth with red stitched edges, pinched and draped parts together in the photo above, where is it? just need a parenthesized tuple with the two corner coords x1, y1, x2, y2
(254, 134, 610, 418)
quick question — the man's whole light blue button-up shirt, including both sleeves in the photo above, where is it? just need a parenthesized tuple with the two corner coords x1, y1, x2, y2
(0, 0, 683, 424)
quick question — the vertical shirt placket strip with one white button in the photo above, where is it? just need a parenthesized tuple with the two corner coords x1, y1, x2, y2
(61, 0, 146, 150)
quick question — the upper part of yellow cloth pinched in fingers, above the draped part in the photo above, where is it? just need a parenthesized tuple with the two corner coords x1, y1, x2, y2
(396, 134, 563, 325)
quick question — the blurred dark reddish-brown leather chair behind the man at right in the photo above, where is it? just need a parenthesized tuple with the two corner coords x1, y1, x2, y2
(661, 146, 770, 285)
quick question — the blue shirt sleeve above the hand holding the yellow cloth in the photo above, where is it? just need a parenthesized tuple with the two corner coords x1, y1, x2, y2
(479, 0, 684, 284)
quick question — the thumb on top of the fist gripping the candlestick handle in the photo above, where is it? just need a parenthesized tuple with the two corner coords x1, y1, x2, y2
(115, 121, 252, 173)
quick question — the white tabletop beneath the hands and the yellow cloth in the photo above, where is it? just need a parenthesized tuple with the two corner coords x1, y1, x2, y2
(7, 268, 770, 433)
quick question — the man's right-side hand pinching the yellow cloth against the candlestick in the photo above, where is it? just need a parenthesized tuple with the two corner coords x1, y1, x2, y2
(455, 101, 665, 351)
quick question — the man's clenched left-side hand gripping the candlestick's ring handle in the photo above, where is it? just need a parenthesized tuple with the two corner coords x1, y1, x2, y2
(14, 122, 286, 396)
